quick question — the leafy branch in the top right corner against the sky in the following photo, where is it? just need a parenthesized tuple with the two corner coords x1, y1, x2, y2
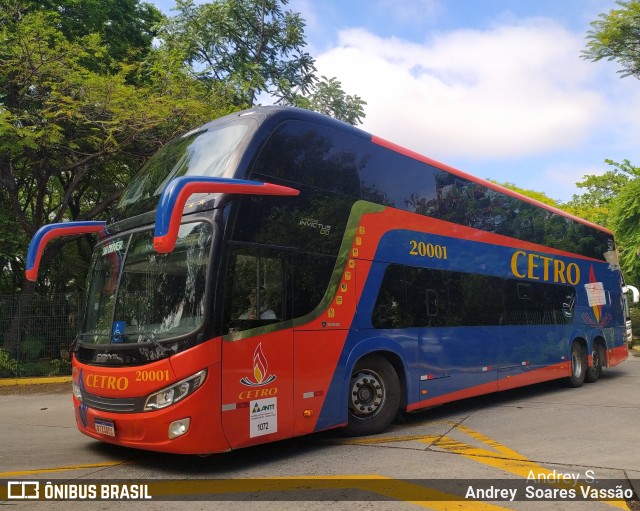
(582, 0, 640, 78)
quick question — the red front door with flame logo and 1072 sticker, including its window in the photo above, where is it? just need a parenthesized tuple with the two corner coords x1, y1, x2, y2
(221, 252, 293, 448)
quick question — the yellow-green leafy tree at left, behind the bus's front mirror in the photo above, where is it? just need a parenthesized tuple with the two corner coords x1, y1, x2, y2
(0, 4, 229, 354)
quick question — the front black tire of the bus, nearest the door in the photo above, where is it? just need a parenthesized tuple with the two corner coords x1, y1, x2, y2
(344, 355, 400, 436)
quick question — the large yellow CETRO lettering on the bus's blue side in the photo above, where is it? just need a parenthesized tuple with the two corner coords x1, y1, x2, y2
(511, 250, 580, 286)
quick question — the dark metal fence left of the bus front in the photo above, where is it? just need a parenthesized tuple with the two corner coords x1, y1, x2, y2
(0, 293, 82, 378)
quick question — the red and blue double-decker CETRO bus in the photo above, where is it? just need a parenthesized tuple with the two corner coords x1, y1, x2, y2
(27, 107, 629, 453)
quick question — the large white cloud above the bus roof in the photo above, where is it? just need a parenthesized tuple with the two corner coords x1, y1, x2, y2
(317, 19, 608, 161)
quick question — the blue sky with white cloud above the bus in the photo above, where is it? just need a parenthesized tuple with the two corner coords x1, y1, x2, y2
(150, 0, 640, 202)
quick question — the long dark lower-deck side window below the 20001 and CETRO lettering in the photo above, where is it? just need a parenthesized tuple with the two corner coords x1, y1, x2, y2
(372, 265, 575, 328)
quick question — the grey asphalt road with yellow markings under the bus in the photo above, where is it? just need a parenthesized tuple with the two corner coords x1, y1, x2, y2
(0, 358, 640, 511)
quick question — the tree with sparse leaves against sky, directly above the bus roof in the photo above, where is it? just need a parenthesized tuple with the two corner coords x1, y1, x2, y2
(159, 0, 366, 124)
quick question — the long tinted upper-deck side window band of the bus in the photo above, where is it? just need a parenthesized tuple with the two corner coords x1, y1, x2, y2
(253, 116, 613, 260)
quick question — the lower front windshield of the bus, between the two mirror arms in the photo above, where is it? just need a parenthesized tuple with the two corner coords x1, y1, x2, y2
(81, 222, 212, 344)
